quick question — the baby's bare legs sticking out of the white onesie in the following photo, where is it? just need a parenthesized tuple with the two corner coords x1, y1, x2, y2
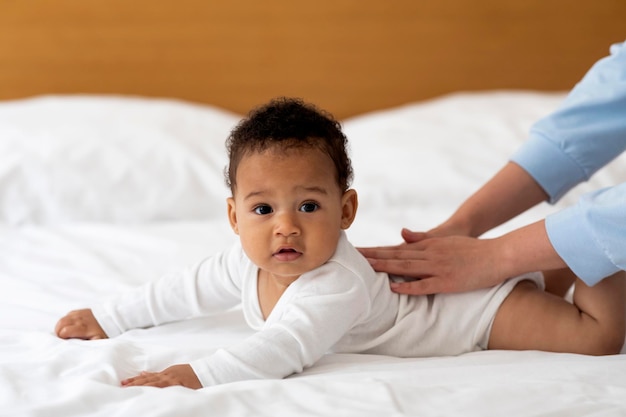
(489, 272, 626, 355)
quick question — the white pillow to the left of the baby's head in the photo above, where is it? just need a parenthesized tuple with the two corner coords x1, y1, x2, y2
(0, 95, 240, 224)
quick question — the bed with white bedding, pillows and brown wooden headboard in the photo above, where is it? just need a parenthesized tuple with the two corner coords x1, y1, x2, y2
(0, 0, 626, 417)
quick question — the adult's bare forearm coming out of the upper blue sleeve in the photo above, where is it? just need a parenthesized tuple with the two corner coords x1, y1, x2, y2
(437, 162, 548, 237)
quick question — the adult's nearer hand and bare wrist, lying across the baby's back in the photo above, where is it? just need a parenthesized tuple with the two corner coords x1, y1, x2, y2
(359, 220, 567, 295)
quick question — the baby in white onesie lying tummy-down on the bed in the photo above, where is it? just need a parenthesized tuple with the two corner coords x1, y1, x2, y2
(55, 99, 625, 388)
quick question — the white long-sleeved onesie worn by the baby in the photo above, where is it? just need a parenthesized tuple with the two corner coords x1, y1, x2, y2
(93, 229, 543, 387)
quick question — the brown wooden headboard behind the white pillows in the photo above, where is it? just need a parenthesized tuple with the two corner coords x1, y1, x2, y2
(0, 0, 626, 118)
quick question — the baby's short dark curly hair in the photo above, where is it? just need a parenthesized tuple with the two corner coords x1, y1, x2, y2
(224, 97, 353, 192)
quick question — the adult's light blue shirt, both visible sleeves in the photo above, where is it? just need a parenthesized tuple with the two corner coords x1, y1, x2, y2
(511, 42, 626, 285)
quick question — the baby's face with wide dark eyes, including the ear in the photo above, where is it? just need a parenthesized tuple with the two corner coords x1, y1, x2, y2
(228, 149, 356, 284)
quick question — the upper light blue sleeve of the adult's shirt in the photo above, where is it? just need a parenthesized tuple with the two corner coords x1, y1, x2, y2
(511, 42, 626, 202)
